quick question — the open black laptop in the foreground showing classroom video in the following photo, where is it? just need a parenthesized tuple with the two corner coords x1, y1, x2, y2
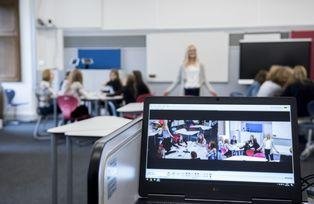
(137, 97, 301, 203)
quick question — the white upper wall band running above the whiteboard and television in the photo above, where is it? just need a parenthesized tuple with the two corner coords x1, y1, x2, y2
(36, 0, 314, 31)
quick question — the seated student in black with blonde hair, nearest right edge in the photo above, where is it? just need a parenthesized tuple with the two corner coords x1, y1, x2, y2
(281, 66, 314, 117)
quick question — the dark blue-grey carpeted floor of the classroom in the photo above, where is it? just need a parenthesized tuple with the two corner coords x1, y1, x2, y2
(0, 123, 314, 204)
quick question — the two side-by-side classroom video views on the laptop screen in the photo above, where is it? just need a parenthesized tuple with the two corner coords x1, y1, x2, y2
(148, 119, 292, 162)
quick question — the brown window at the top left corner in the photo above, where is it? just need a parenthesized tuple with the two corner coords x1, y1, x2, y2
(0, 0, 21, 82)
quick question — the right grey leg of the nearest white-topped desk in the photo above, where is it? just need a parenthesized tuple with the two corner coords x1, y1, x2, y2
(66, 136, 73, 204)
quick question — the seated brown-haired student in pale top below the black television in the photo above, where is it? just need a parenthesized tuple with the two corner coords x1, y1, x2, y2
(257, 65, 292, 97)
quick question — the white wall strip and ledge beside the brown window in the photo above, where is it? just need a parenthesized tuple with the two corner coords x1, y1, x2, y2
(2, 0, 36, 120)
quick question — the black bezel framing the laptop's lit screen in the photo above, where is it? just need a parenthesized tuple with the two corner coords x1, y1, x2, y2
(139, 97, 302, 203)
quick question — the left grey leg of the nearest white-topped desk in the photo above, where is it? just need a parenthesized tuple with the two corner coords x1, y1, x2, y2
(51, 134, 58, 204)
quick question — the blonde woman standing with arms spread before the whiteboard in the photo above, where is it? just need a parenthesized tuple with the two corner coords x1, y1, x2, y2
(164, 45, 217, 96)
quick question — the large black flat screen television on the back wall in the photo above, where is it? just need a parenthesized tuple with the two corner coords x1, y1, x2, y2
(239, 39, 311, 84)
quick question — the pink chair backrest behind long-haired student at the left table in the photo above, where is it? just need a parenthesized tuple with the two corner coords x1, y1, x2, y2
(57, 95, 78, 120)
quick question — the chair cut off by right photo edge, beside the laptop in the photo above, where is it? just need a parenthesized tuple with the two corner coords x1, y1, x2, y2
(299, 100, 314, 160)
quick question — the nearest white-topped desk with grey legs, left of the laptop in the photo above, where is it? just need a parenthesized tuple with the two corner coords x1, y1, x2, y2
(48, 116, 131, 204)
